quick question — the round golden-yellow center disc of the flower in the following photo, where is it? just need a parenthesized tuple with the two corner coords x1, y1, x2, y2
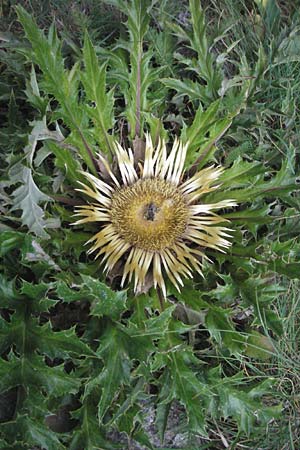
(111, 178, 188, 251)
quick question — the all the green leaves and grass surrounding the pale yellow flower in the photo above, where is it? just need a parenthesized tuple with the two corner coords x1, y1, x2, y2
(0, 0, 300, 450)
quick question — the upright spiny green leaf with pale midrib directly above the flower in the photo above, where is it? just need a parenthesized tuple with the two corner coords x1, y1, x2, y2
(106, 0, 157, 139)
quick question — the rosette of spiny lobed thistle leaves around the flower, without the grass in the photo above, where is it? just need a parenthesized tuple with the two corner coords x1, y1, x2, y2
(0, 0, 299, 450)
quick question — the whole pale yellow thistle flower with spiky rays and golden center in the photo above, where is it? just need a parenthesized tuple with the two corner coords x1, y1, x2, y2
(74, 135, 236, 296)
